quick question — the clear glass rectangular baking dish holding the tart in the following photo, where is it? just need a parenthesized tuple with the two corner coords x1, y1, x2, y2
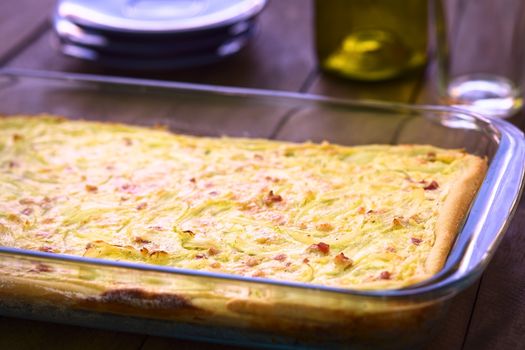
(0, 69, 525, 349)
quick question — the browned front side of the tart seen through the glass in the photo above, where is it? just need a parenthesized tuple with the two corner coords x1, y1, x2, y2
(0, 270, 444, 343)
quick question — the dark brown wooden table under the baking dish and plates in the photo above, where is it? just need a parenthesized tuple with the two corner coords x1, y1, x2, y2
(0, 0, 525, 350)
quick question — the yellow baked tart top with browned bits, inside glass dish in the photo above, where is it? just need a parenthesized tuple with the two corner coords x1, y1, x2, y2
(0, 116, 487, 290)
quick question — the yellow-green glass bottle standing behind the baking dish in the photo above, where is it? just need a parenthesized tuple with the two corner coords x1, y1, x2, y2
(315, 0, 428, 81)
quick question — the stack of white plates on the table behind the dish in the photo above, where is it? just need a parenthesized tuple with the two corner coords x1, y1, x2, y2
(53, 0, 266, 69)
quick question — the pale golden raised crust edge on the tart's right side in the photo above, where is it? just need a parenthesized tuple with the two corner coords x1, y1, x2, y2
(425, 155, 487, 275)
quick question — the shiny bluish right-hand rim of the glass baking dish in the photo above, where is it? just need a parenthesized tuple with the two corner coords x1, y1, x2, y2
(456, 119, 525, 275)
